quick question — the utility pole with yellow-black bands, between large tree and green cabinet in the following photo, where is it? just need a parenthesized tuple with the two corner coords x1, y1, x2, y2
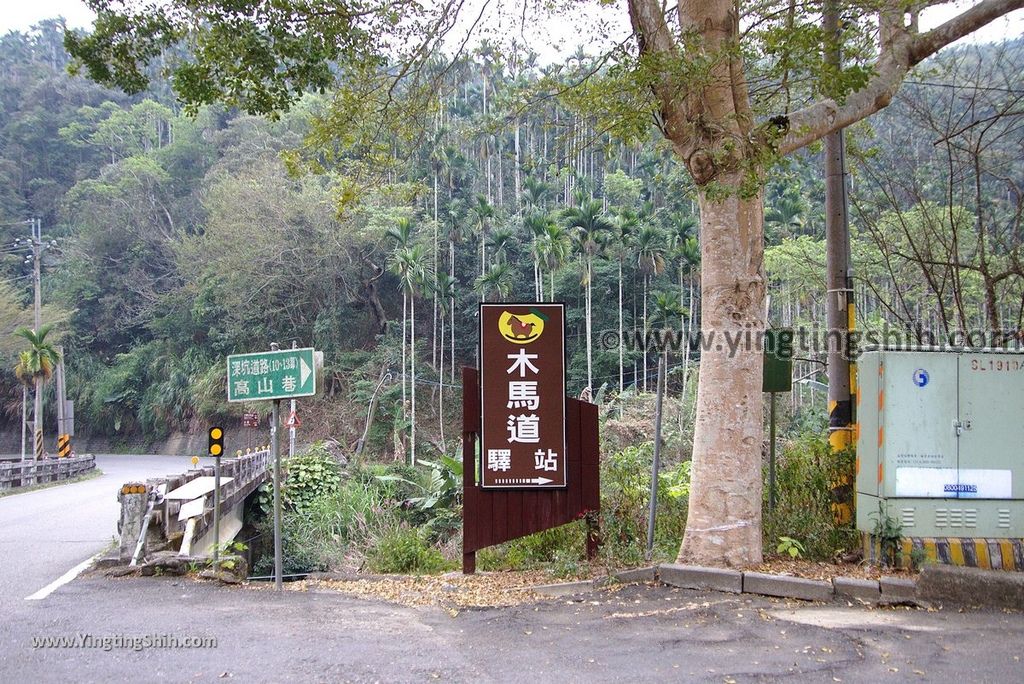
(822, 0, 854, 522)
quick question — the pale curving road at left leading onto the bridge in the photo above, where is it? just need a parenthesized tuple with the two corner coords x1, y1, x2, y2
(0, 455, 210, 610)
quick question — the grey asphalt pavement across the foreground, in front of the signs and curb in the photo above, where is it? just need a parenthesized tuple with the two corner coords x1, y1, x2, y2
(0, 576, 1024, 684)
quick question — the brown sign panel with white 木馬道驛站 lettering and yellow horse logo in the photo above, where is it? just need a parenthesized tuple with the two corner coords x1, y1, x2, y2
(479, 304, 568, 488)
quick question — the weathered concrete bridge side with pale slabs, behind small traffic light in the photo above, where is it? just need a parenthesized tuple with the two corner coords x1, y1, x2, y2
(118, 446, 271, 560)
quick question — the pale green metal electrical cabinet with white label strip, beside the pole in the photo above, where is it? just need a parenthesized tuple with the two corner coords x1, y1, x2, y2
(857, 350, 1024, 538)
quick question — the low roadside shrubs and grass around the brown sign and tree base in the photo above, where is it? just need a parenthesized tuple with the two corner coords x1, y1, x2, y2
(247, 389, 858, 579)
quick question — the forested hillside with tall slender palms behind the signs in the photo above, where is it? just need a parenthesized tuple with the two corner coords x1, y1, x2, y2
(0, 18, 1022, 458)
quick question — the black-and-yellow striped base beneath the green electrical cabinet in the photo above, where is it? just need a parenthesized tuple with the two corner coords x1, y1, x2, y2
(861, 532, 1024, 570)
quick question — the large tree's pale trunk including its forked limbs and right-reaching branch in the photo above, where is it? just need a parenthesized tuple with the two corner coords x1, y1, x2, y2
(628, 0, 1024, 565)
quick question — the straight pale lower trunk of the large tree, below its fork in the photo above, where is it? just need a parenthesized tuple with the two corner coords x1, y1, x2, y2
(679, 184, 765, 566)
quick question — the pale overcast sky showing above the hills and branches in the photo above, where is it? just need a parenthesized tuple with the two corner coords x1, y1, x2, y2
(0, 0, 1024, 56)
